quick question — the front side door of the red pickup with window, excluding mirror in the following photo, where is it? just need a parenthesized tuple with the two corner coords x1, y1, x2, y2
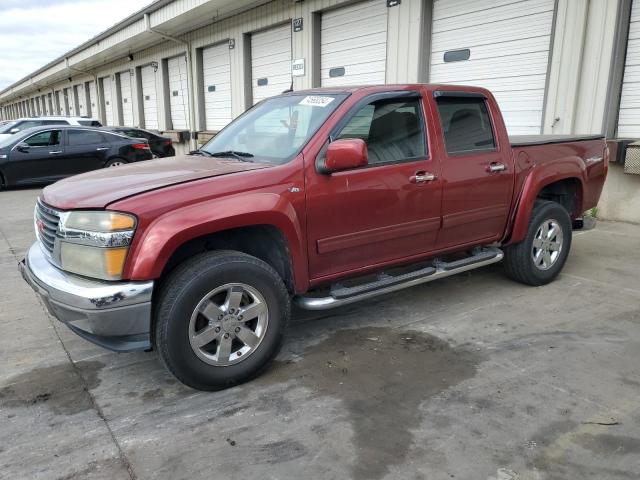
(306, 91, 442, 281)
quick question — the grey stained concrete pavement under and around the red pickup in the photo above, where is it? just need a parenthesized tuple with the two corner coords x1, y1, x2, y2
(0, 189, 640, 480)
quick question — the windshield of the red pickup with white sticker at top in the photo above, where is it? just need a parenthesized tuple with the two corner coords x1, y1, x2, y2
(200, 94, 346, 165)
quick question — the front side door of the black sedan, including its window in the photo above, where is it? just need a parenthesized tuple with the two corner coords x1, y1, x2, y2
(8, 130, 64, 183)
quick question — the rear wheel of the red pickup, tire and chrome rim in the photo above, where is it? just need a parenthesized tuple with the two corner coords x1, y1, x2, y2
(504, 200, 571, 286)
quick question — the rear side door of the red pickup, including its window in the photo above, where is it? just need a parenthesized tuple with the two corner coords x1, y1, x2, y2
(435, 91, 514, 248)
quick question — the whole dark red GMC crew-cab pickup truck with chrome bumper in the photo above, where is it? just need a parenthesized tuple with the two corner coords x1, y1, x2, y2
(21, 85, 608, 390)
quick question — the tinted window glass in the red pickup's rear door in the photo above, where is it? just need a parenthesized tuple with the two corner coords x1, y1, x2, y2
(437, 97, 496, 154)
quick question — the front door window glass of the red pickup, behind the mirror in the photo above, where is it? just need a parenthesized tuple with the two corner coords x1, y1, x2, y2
(337, 99, 426, 164)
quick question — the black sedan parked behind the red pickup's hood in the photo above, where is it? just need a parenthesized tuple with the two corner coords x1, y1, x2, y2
(0, 125, 153, 189)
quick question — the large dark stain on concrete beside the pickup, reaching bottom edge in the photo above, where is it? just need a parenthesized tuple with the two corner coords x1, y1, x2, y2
(259, 328, 484, 479)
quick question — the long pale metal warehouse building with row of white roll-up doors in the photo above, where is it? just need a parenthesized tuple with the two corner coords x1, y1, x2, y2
(0, 0, 640, 221)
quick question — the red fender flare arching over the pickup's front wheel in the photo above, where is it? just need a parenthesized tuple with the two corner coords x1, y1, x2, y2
(123, 192, 308, 290)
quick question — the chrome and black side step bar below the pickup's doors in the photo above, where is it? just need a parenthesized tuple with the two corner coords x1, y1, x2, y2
(295, 247, 504, 310)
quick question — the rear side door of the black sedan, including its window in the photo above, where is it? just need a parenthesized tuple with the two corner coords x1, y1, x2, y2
(65, 129, 109, 175)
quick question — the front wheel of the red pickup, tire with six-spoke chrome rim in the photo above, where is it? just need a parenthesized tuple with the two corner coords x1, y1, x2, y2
(154, 251, 291, 390)
